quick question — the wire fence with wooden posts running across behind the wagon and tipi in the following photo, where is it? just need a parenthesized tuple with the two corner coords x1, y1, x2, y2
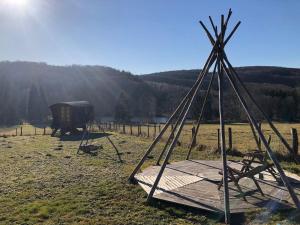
(0, 122, 300, 154)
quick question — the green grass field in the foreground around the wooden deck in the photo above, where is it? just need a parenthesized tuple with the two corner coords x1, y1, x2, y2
(0, 124, 300, 224)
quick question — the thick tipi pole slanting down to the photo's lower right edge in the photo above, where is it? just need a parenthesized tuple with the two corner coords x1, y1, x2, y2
(221, 58, 300, 208)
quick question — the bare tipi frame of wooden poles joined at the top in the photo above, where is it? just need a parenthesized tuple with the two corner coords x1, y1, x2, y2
(129, 9, 300, 223)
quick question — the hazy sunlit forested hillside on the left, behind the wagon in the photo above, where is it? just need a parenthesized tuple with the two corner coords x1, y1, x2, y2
(0, 62, 188, 125)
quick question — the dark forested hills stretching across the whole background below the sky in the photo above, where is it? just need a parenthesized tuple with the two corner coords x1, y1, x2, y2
(0, 62, 300, 125)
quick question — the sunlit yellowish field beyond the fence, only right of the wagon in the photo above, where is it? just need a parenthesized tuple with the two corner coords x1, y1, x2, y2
(103, 123, 300, 155)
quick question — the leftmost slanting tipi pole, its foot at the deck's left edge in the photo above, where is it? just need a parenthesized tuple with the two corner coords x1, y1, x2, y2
(128, 44, 216, 182)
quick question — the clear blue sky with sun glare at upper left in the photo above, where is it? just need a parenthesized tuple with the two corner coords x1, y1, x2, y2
(0, 0, 300, 74)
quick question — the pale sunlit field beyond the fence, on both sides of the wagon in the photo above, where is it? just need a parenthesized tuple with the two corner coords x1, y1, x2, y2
(0, 123, 300, 157)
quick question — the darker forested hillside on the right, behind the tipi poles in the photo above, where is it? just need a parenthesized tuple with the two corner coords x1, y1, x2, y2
(141, 66, 300, 121)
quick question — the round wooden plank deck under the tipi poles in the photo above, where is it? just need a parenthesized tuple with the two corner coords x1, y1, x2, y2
(135, 160, 300, 213)
